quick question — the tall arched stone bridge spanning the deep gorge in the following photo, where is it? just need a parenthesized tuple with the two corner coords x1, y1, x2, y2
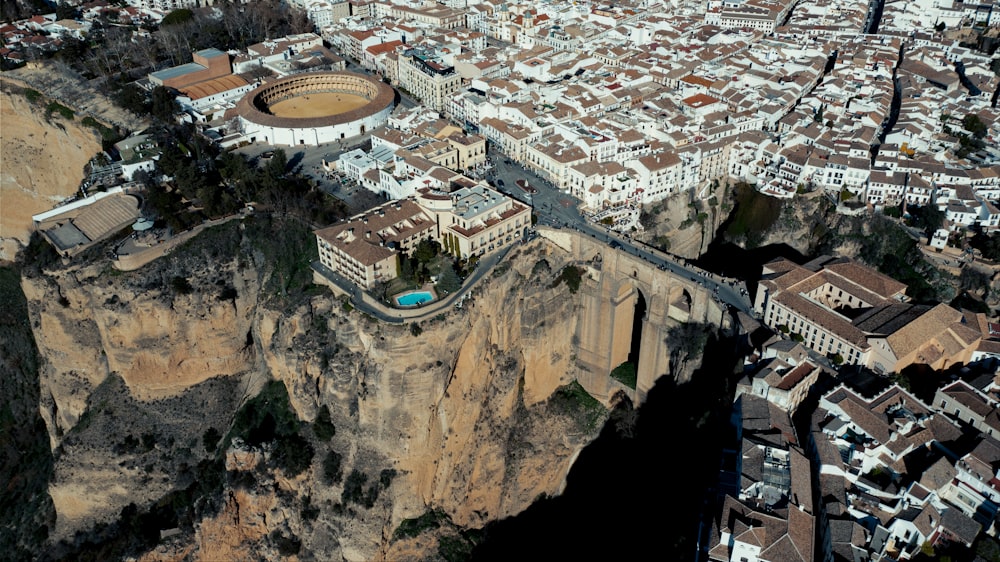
(539, 228, 729, 405)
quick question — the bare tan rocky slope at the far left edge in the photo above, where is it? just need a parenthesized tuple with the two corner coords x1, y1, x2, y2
(0, 81, 101, 260)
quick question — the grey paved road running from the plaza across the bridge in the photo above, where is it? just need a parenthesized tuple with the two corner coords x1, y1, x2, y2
(486, 142, 753, 314)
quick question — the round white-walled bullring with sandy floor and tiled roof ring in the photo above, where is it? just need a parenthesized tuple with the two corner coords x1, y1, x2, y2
(237, 72, 396, 146)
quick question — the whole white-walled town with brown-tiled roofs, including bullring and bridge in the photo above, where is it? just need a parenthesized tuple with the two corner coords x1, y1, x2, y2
(0, 0, 1000, 562)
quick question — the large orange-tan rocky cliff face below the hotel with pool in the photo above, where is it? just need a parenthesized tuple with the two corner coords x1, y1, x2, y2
(23, 225, 598, 560)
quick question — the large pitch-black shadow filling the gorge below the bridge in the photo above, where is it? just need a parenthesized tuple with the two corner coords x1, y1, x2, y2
(471, 330, 737, 561)
